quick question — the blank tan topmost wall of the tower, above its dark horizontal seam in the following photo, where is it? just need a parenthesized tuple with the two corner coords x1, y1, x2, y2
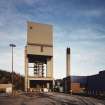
(27, 22, 53, 45)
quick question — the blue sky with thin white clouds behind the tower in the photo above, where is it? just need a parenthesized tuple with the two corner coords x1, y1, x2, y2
(0, 0, 105, 78)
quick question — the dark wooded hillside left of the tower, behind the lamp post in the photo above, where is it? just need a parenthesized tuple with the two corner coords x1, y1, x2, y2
(0, 69, 24, 90)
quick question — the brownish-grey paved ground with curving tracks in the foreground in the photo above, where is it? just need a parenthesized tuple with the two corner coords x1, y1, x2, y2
(0, 93, 105, 105)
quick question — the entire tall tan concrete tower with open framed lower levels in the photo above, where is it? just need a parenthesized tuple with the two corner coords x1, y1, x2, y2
(25, 22, 53, 91)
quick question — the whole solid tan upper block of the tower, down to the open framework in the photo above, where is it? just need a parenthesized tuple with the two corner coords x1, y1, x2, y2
(27, 22, 53, 56)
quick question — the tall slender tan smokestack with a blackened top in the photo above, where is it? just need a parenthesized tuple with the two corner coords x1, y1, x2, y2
(66, 48, 70, 77)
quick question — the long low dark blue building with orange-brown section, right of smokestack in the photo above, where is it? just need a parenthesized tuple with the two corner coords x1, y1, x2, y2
(62, 70, 105, 95)
